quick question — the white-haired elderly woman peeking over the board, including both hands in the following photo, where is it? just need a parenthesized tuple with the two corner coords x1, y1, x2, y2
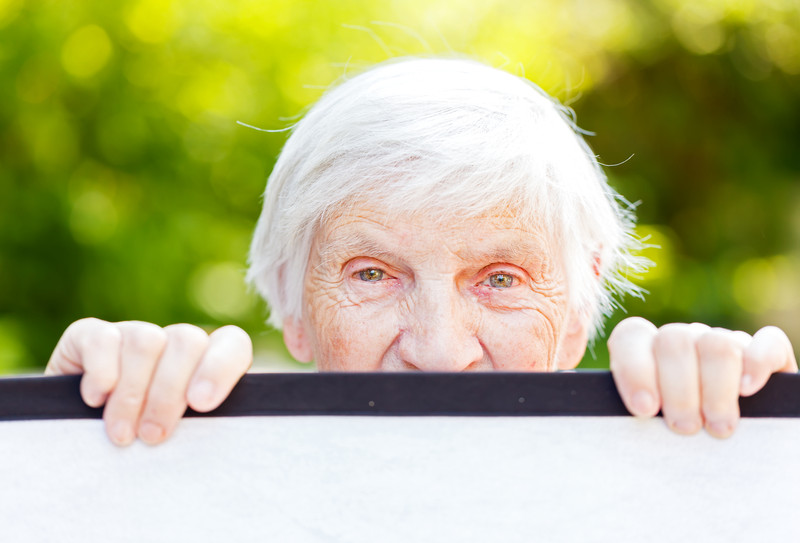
(46, 59, 797, 445)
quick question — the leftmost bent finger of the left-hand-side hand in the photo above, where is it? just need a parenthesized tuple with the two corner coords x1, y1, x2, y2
(45, 318, 122, 407)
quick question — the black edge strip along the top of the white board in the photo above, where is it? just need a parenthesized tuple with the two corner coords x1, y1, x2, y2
(0, 371, 800, 420)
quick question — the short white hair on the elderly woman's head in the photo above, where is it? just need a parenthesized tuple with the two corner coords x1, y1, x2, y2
(248, 58, 644, 337)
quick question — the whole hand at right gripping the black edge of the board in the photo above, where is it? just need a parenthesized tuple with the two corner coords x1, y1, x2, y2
(608, 317, 798, 438)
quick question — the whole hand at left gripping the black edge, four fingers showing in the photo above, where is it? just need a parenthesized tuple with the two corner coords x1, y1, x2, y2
(45, 318, 253, 446)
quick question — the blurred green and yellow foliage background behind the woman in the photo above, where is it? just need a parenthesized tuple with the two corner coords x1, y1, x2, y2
(0, 0, 800, 373)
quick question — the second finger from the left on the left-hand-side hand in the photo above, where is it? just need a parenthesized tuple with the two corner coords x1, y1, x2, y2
(103, 322, 167, 445)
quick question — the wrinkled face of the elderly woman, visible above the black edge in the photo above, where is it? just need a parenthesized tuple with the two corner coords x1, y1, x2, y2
(284, 208, 586, 371)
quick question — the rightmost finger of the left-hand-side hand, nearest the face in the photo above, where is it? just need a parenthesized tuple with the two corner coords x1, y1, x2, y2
(186, 326, 253, 412)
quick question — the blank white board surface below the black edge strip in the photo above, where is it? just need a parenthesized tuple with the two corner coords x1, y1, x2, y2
(0, 416, 800, 542)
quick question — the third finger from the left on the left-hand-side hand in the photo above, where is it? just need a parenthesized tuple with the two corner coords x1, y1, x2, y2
(137, 324, 209, 445)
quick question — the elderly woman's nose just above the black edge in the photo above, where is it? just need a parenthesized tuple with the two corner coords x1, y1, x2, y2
(398, 285, 484, 372)
